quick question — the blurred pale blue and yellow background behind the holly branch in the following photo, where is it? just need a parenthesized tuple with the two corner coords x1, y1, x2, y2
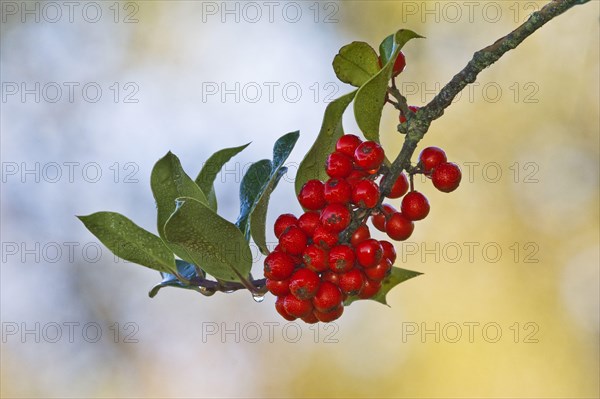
(0, 1, 600, 398)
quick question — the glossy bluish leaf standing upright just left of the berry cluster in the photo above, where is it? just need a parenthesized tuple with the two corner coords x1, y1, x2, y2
(235, 159, 272, 240)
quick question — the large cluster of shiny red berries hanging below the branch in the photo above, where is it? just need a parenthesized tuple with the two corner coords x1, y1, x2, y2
(264, 135, 460, 323)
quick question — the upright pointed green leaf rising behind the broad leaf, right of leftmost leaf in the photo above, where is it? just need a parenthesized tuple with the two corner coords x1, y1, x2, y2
(150, 151, 208, 263)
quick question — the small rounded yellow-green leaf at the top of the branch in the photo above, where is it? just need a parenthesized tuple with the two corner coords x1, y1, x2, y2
(333, 42, 379, 87)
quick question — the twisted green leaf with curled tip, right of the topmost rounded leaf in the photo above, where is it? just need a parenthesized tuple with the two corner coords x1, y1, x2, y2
(354, 29, 423, 142)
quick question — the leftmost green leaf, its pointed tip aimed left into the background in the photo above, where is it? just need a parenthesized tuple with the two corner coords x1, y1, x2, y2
(77, 212, 176, 273)
